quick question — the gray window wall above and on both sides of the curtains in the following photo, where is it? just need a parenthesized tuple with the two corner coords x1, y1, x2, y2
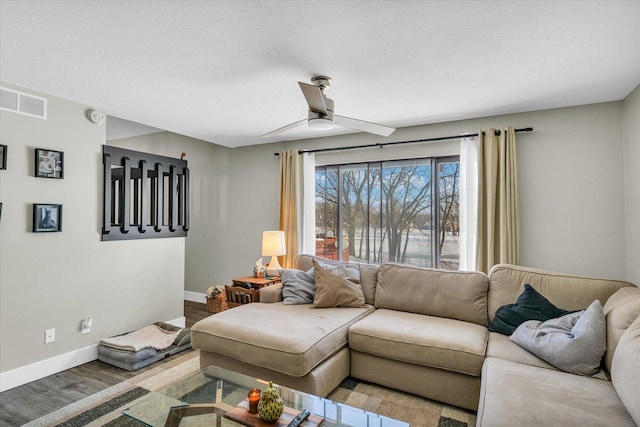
(206, 102, 626, 284)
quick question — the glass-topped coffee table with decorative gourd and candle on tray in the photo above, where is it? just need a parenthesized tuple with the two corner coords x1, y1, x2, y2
(122, 366, 409, 427)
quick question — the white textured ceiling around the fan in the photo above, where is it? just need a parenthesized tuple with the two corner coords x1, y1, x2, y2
(0, 0, 640, 147)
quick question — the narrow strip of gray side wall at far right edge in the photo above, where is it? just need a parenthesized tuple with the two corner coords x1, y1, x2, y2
(622, 86, 640, 286)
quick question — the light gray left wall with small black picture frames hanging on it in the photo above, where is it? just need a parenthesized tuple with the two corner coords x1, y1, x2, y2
(0, 83, 185, 372)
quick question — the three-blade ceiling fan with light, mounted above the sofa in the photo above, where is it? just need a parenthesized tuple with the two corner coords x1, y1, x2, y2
(260, 76, 396, 138)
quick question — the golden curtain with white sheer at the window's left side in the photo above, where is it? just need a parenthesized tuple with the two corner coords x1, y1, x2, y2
(278, 150, 315, 268)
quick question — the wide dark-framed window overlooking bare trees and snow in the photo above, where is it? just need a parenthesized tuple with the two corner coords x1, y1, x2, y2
(315, 156, 460, 270)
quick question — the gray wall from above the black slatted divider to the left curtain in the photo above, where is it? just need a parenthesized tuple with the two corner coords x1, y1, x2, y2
(109, 132, 279, 293)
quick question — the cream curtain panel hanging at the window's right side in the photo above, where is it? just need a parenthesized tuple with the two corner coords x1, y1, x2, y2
(475, 126, 520, 273)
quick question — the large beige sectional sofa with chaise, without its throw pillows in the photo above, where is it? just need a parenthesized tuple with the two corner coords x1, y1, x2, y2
(192, 255, 640, 426)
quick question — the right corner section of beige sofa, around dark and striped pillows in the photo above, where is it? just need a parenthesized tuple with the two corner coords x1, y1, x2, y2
(477, 265, 640, 427)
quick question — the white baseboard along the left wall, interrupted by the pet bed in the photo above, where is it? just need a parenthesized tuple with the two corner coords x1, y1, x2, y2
(0, 316, 186, 392)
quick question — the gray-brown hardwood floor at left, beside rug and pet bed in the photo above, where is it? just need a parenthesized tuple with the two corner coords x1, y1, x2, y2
(0, 301, 211, 427)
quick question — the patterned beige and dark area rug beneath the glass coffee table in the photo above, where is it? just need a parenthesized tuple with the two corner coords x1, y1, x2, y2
(26, 352, 476, 427)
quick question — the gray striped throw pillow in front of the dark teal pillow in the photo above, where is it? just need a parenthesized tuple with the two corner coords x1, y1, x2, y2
(509, 300, 607, 375)
